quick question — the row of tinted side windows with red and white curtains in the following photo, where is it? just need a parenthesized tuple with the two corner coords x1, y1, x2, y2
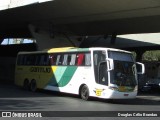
(17, 53, 91, 66)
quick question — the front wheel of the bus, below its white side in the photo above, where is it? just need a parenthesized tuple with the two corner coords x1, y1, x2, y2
(80, 85, 89, 100)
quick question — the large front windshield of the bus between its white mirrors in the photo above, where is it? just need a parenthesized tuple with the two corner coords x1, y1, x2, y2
(108, 51, 137, 86)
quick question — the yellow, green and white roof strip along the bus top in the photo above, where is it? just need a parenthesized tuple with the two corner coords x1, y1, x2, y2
(18, 47, 131, 54)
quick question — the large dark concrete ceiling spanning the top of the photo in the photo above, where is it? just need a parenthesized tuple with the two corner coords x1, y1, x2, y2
(0, 0, 160, 37)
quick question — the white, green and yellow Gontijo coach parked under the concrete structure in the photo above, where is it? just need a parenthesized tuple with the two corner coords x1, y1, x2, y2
(15, 47, 144, 100)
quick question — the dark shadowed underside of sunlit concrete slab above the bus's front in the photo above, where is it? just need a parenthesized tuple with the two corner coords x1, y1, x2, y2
(80, 36, 160, 52)
